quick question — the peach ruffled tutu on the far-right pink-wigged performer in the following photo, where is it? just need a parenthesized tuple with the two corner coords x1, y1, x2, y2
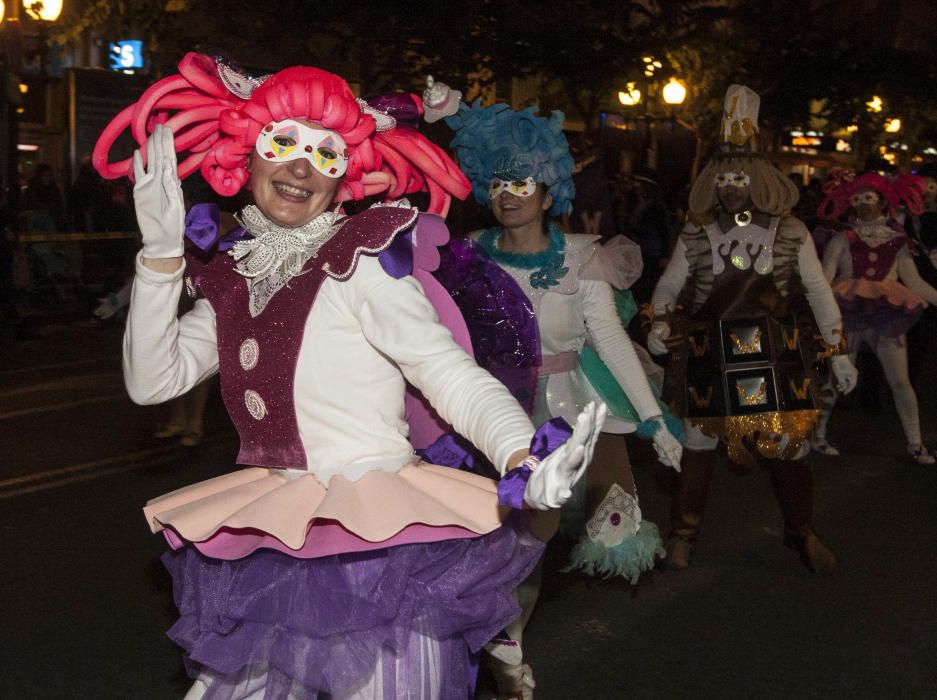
(832, 278, 927, 338)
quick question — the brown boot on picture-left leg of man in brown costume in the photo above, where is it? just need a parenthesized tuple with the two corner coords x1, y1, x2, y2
(664, 450, 716, 569)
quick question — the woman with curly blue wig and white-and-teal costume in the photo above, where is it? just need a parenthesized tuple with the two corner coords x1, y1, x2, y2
(437, 91, 681, 697)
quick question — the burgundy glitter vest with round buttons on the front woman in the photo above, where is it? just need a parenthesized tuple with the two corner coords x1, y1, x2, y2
(192, 207, 417, 468)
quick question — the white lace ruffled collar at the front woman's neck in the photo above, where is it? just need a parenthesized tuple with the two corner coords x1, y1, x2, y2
(228, 204, 341, 316)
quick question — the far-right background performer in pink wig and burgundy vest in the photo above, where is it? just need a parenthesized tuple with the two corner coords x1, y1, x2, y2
(815, 172, 937, 465)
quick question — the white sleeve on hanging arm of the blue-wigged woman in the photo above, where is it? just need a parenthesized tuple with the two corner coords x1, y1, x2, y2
(579, 280, 661, 420)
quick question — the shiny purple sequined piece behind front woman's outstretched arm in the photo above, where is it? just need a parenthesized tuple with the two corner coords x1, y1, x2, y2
(433, 239, 540, 413)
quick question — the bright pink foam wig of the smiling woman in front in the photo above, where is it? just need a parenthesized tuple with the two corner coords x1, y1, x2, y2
(92, 53, 471, 216)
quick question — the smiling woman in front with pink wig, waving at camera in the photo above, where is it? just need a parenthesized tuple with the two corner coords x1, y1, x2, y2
(94, 54, 604, 699)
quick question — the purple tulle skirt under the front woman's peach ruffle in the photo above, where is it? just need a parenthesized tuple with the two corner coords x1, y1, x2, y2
(163, 512, 543, 700)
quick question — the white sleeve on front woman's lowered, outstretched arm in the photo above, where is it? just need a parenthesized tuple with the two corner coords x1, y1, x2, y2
(349, 257, 534, 473)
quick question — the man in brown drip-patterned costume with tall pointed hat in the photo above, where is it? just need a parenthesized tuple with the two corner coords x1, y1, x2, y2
(648, 85, 856, 571)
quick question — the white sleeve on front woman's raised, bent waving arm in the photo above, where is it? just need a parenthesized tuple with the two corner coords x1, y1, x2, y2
(123, 253, 218, 404)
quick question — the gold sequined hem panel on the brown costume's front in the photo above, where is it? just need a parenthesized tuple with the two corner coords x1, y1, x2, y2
(690, 408, 820, 464)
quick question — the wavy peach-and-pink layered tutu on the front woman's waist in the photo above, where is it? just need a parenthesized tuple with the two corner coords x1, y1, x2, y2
(143, 463, 506, 559)
